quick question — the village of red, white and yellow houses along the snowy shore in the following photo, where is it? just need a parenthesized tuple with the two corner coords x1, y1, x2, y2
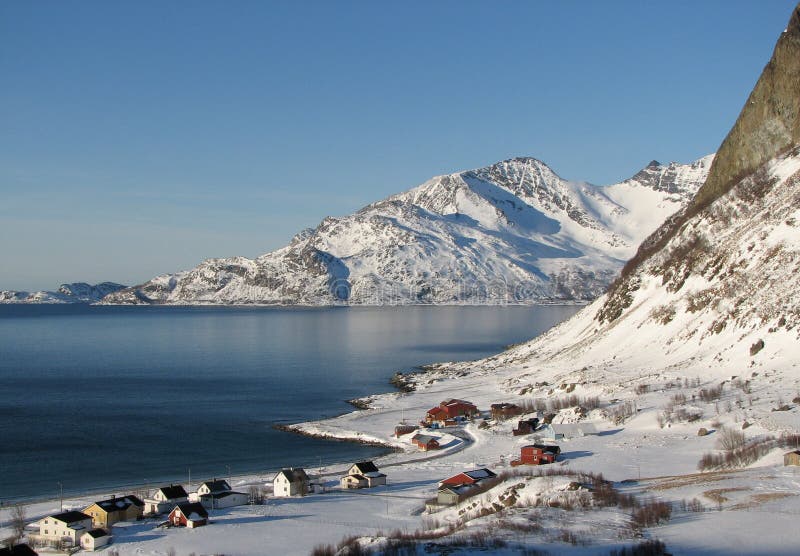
(0, 399, 594, 556)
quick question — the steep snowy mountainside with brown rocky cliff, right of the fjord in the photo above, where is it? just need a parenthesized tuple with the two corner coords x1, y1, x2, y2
(468, 7, 800, 402)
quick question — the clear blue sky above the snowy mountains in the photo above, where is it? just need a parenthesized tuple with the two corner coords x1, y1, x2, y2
(0, 0, 794, 290)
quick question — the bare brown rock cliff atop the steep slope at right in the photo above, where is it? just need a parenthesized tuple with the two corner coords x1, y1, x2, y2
(597, 6, 800, 322)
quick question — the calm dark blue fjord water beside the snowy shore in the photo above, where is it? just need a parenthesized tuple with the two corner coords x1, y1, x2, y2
(0, 305, 578, 502)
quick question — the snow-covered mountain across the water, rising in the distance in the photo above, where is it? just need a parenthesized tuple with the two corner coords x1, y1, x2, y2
(103, 155, 713, 305)
